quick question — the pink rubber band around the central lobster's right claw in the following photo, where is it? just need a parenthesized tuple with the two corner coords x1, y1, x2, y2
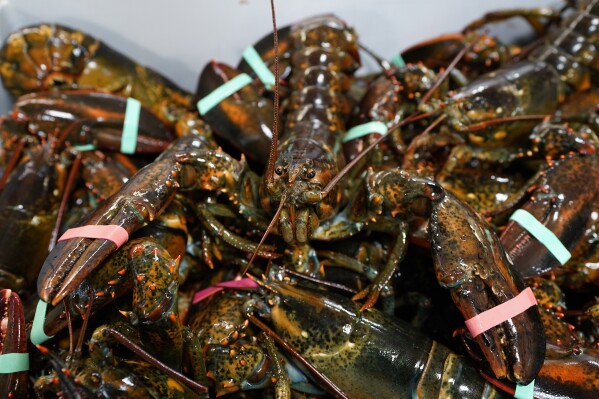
(466, 287, 537, 337)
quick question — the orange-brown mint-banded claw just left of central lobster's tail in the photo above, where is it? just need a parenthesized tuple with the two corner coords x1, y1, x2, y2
(196, 62, 273, 162)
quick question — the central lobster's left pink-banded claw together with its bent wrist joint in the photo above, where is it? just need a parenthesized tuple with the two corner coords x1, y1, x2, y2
(37, 135, 231, 306)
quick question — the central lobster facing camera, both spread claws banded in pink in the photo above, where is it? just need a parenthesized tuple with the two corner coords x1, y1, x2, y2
(28, 9, 544, 388)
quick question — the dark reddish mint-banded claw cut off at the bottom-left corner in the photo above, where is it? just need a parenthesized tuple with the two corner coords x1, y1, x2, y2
(0, 289, 27, 398)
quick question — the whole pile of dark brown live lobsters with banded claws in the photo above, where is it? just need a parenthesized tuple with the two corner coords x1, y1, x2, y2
(0, 0, 599, 398)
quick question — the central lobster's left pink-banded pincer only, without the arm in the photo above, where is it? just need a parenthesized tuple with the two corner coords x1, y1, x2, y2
(37, 136, 214, 306)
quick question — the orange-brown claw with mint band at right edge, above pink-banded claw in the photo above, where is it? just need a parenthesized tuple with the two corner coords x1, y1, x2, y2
(501, 155, 599, 277)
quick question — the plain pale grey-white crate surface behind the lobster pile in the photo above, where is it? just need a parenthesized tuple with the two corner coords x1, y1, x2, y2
(0, 0, 559, 114)
